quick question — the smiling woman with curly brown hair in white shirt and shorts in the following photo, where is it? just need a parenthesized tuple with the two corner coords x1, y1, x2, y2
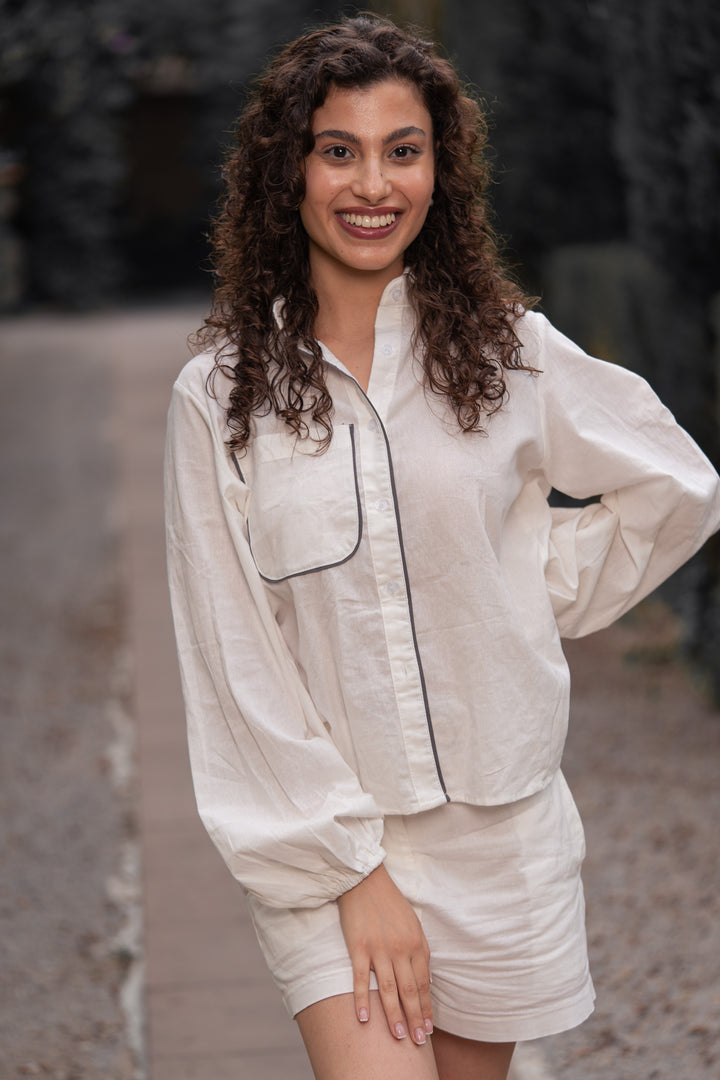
(167, 10, 720, 1080)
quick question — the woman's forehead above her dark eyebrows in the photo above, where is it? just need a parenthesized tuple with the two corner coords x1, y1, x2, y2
(312, 79, 432, 136)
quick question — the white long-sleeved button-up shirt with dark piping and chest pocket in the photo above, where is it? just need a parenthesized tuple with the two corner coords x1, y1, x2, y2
(166, 279, 720, 906)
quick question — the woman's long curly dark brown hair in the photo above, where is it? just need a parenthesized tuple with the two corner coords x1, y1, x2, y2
(194, 15, 532, 450)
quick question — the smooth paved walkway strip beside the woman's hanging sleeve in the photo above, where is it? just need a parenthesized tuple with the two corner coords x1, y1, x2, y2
(111, 312, 312, 1080)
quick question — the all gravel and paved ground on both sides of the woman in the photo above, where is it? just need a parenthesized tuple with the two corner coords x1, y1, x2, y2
(0, 305, 720, 1080)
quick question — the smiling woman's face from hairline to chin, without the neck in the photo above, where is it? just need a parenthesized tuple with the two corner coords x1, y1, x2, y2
(300, 79, 435, 283)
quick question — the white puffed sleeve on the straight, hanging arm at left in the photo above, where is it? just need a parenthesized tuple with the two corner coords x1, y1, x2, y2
(165, 362, 384, 907)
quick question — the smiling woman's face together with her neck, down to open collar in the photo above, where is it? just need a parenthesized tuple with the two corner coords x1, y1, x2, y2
(300, 79, 435, 389)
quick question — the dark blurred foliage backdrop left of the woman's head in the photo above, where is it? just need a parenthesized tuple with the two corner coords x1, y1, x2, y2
(0, 0, 338, 308)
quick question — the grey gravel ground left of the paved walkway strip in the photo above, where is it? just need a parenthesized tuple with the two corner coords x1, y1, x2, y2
(0, 316, 138, 1080)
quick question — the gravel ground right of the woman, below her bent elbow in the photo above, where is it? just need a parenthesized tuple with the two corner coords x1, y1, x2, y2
(539, 602, 720, 1080)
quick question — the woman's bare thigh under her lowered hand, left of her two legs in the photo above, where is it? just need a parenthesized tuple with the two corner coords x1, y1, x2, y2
(296, 990, 442, 1080)
